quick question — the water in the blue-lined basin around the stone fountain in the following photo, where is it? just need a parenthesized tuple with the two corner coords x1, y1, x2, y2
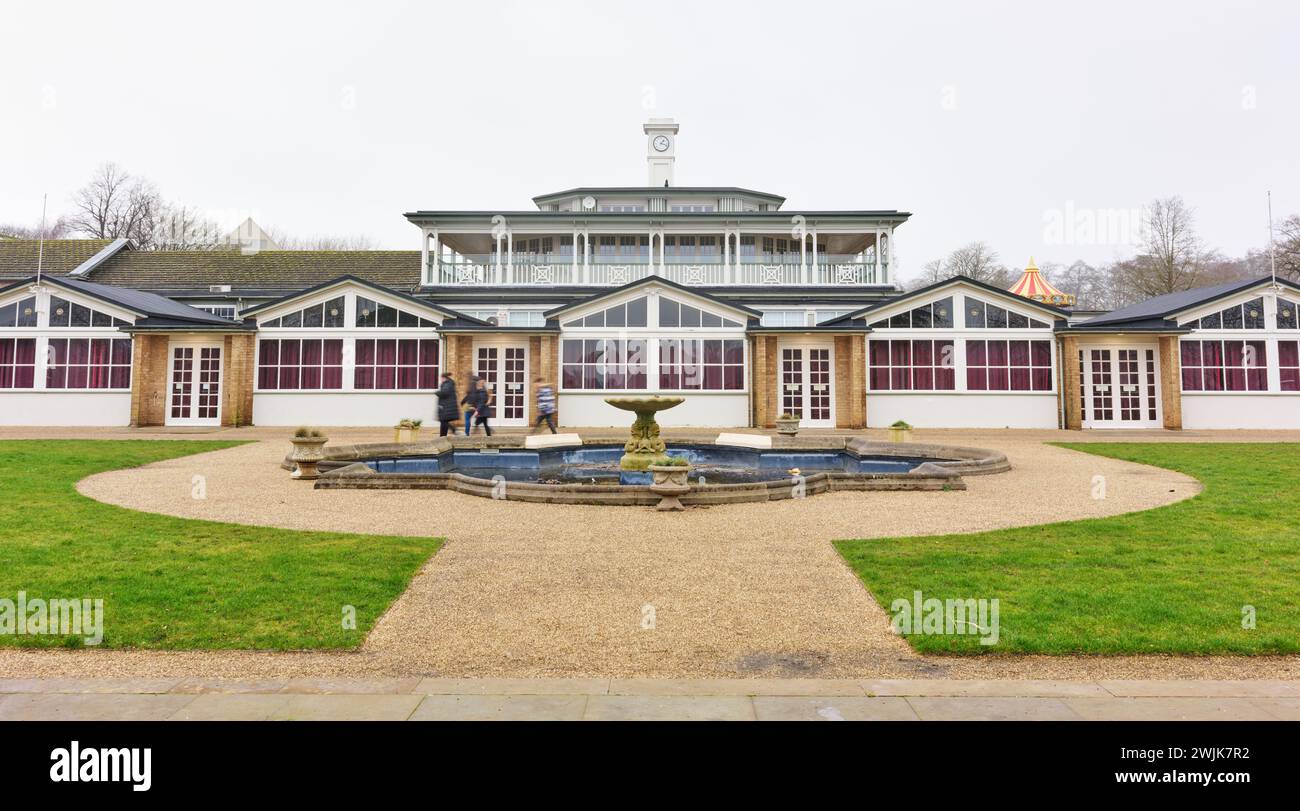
(365, 444, 943, 485)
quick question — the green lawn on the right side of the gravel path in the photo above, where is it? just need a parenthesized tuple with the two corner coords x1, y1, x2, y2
(836, 443, 1300, 654)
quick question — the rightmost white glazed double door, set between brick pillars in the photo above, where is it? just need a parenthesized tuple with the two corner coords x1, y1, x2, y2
(1082, 347, 1162, 428)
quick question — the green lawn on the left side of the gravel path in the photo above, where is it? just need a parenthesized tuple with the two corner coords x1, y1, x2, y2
(0, 441, 442, 649)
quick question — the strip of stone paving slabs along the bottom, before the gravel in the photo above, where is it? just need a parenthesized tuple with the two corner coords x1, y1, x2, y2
(0, 678, 1300, 721)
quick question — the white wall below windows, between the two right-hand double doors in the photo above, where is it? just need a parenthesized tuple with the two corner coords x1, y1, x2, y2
(867, 391, 1057, 429)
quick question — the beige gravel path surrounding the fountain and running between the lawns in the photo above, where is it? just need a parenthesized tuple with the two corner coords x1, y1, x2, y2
(0, 429, 1300, 678)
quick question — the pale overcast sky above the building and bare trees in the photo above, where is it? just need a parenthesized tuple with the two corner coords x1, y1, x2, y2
(0, 0, 1300, 276)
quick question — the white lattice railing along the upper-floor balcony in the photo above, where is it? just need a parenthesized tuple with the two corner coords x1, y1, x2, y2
(434, 255, 889, 287)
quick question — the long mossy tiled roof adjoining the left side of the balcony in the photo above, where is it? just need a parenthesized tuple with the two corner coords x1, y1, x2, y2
(92, 250, 420, 292)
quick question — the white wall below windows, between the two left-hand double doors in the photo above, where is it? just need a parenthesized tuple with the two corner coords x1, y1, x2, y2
(252, 391, 436, 426)
